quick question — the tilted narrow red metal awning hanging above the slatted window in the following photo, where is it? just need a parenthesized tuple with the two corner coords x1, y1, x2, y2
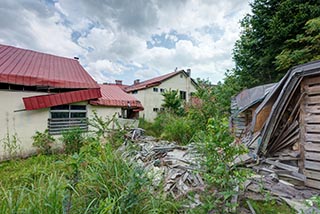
(23, 88, 100, 110)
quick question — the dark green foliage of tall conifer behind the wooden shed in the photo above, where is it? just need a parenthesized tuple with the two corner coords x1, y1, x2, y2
(233, 0, 320, 88)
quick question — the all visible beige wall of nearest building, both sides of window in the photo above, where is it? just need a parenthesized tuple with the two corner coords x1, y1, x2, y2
(0, 90, 138, 160)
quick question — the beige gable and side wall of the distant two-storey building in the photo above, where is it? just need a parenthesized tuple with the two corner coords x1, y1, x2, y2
(133, 74, 196, 122)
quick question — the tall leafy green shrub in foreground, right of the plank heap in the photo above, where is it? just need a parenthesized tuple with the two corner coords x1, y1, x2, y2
(194, 118, 250, 212)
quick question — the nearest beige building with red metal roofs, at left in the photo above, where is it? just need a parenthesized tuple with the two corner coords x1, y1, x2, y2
(0, 45, 143, 159)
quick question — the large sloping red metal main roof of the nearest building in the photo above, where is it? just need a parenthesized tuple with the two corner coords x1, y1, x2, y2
(0, 44, 99, 88)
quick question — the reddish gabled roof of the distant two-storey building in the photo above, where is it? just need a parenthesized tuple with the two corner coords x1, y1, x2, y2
(126, 70, 197, 92)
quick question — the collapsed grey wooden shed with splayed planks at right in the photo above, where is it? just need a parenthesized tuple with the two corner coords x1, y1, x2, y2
(231, 61, 320, 189)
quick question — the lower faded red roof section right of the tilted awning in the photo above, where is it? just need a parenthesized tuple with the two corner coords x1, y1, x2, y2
(90, 84, 143, 110)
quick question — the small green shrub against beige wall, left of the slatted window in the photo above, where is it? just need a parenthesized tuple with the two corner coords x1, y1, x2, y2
(32, 129, 55, 154)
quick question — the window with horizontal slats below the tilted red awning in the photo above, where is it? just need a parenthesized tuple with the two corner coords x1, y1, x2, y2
(48, 105, 88, 135)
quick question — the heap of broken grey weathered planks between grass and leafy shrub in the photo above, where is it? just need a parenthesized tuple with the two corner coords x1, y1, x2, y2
(120, 133, 205, 207)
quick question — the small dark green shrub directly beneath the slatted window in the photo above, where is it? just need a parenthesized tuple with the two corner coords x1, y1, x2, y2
(61, 128, 85, 154)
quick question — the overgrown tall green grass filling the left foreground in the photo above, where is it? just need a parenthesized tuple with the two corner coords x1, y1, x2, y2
(0, 140, 180, 213)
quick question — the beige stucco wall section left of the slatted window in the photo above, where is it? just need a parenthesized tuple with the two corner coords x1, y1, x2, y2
(0, 90, 49, 159)
